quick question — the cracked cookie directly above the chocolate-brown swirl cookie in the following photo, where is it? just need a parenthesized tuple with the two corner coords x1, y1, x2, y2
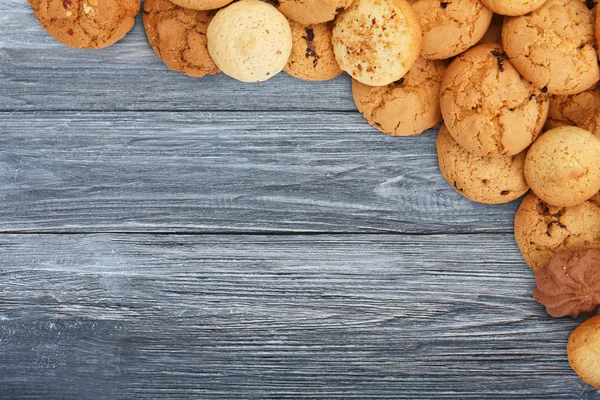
(515, 193, 600, 270)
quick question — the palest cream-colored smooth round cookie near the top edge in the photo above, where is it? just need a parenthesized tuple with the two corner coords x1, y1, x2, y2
(206, 0, 292, 82)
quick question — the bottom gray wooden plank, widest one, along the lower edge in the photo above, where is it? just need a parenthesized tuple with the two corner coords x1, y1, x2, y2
(0, 234, 600, 400)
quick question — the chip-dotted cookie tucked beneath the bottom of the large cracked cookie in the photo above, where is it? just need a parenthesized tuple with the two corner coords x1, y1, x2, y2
(437, 125, 529, 204)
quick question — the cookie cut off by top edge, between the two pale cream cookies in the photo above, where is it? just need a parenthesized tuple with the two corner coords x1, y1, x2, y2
(272, 0, 353, 25)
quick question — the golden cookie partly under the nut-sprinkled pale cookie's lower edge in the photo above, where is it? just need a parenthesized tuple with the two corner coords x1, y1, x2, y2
(352, 58, 446, 136)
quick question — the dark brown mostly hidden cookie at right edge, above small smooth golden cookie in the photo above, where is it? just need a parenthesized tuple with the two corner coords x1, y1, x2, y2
(544, 85, 600, 133)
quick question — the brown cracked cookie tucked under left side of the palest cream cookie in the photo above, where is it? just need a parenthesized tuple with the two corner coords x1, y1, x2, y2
(143, 0, 219, 77)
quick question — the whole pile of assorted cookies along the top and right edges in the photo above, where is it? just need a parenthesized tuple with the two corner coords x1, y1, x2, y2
(29, 0, 600, 388)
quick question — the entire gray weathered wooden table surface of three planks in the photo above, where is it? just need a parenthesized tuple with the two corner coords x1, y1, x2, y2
(0, 0, 600, 400)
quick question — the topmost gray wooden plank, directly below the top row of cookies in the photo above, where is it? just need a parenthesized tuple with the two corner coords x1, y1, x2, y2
(0, 0, 355, 111)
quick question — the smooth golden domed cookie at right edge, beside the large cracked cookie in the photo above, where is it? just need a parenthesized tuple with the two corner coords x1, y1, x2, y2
(525, 126, 600, 207)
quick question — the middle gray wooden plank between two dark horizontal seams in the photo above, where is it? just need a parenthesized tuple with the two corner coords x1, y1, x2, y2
(0, 112, 518, 233)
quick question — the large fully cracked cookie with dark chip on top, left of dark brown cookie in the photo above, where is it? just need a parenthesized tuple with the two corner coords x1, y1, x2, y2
(440, 43, 548, 156)
